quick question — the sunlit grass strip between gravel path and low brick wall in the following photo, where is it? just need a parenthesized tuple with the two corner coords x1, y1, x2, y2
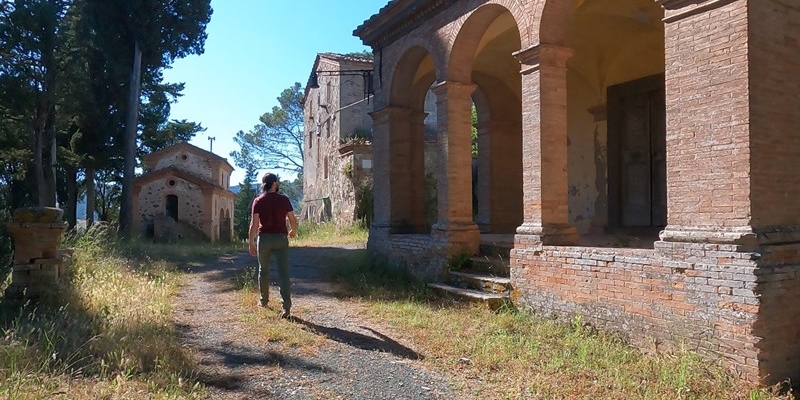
(333, 248, 791, 400)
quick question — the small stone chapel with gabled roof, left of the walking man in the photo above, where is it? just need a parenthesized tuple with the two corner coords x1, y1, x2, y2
(134, 142, 236, 242)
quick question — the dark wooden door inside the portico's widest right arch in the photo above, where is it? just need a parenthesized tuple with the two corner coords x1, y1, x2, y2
(608, 74, 667, 228)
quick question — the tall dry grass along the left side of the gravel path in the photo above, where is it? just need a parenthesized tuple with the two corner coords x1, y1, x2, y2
(0, 225, 244, 399)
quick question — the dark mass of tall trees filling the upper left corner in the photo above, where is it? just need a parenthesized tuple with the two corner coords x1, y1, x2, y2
(0, 0, 212, 244)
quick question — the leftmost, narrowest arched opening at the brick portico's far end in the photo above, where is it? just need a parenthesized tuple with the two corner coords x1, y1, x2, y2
(388, 47, 439, 234)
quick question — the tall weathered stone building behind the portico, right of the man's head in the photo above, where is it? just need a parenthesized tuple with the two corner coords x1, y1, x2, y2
(299, 53, 372, 225)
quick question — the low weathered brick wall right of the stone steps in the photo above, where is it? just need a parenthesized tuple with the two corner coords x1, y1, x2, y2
(511, 241, 800, 383)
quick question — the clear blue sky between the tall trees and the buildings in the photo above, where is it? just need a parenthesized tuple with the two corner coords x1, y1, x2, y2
(164, 0, 388, 185)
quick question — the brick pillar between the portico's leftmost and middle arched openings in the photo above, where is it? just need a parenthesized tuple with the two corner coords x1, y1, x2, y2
(432, 82, 480, 253)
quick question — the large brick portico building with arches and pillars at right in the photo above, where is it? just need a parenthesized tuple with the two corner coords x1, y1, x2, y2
(355, 0, 800, 383)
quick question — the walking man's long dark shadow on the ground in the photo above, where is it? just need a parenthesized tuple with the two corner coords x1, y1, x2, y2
(292, 317, 424, 360)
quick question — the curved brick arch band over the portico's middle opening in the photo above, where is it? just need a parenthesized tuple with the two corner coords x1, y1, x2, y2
(447, 0, 527, 82)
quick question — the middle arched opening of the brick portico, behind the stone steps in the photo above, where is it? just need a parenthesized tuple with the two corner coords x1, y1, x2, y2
(448, 5, 523, 234)
